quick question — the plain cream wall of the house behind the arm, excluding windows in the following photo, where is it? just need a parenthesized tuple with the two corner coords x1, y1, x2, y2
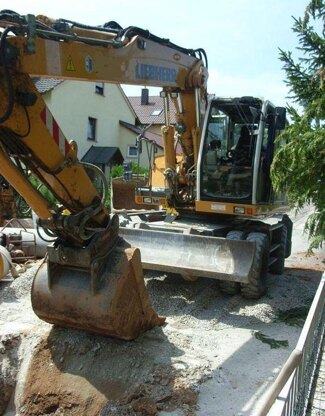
(43, 80, 136, 164)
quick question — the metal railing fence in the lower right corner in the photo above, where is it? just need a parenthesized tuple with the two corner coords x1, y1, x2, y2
(257, 273, 325, 416)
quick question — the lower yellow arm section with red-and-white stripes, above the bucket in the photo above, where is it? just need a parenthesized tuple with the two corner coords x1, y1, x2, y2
(0, 74, 108, 242)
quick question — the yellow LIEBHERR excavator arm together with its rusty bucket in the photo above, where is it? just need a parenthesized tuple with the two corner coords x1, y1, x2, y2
(0, 11, 207, 339)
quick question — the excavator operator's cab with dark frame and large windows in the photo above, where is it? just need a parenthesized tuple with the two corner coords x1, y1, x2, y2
(197, 97, 285, 214)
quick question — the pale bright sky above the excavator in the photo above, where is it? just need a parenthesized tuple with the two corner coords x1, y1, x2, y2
(0, 0, 308, 105)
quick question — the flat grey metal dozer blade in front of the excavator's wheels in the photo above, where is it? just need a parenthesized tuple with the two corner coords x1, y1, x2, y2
(119, 227, 255, 283)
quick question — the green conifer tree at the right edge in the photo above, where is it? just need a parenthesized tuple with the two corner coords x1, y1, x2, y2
(271, 0, 325, 251)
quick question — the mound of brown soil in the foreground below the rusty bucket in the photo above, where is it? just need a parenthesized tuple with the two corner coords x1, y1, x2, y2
(20, 328, 198, 416)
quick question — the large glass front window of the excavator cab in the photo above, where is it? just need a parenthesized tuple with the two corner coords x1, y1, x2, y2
(201, 104, 258, 200)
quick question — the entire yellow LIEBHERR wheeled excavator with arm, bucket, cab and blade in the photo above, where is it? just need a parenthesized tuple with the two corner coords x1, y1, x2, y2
(0, 10, 291, 339)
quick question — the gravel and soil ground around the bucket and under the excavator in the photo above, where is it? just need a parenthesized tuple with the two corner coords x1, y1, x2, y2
(0, 210, 324, 416)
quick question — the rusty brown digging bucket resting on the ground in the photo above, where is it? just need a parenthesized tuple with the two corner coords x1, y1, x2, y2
(32, 240, 165, 340)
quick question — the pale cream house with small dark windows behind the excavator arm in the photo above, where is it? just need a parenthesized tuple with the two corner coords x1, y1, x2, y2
(34, 78, 163, 175)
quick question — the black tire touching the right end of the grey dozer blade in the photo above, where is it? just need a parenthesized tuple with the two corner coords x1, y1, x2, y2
(241, 233, 269, 299)
